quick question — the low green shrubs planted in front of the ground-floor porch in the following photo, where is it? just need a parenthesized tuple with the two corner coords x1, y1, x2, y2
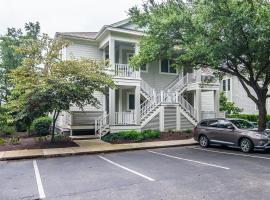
(102, 130, 160, 142)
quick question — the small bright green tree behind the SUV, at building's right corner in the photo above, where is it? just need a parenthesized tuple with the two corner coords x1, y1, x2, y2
(219, 92, 243, 114)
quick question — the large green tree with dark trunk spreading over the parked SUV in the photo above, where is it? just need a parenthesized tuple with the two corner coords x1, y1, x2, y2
(129, 0, 270, 131)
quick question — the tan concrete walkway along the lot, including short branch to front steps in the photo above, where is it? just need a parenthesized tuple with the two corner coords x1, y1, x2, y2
(0, 139, 197, 161)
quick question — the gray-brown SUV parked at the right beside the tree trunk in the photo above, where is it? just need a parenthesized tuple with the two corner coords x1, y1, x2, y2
(194, 118, 270, 153)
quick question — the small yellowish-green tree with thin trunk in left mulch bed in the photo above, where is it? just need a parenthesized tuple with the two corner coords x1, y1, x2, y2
(9, 34, 114, 141)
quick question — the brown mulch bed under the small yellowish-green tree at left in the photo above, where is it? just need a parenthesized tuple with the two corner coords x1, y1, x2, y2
(0, 133, 78, 151)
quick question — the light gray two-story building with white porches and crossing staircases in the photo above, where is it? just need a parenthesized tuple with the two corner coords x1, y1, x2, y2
(56, 19, 224, 136)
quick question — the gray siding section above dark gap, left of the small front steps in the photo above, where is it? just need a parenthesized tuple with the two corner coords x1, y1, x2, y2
(72, 112, 103, 126)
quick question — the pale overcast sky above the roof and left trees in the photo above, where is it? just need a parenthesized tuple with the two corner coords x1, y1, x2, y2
(0, 0, 142, 36)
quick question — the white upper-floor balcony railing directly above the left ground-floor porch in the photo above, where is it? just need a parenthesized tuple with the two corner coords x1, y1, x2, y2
(114, 64, 140, 78)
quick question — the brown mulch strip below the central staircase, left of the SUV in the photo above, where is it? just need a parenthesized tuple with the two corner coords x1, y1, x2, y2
(107, 132, 193, 144)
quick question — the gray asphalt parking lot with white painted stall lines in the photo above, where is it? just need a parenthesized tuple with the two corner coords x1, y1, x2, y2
(0, 146, 270, 200)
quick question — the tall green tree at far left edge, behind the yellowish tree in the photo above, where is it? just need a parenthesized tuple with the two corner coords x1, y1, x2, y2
(0, 22, 40, 106)
